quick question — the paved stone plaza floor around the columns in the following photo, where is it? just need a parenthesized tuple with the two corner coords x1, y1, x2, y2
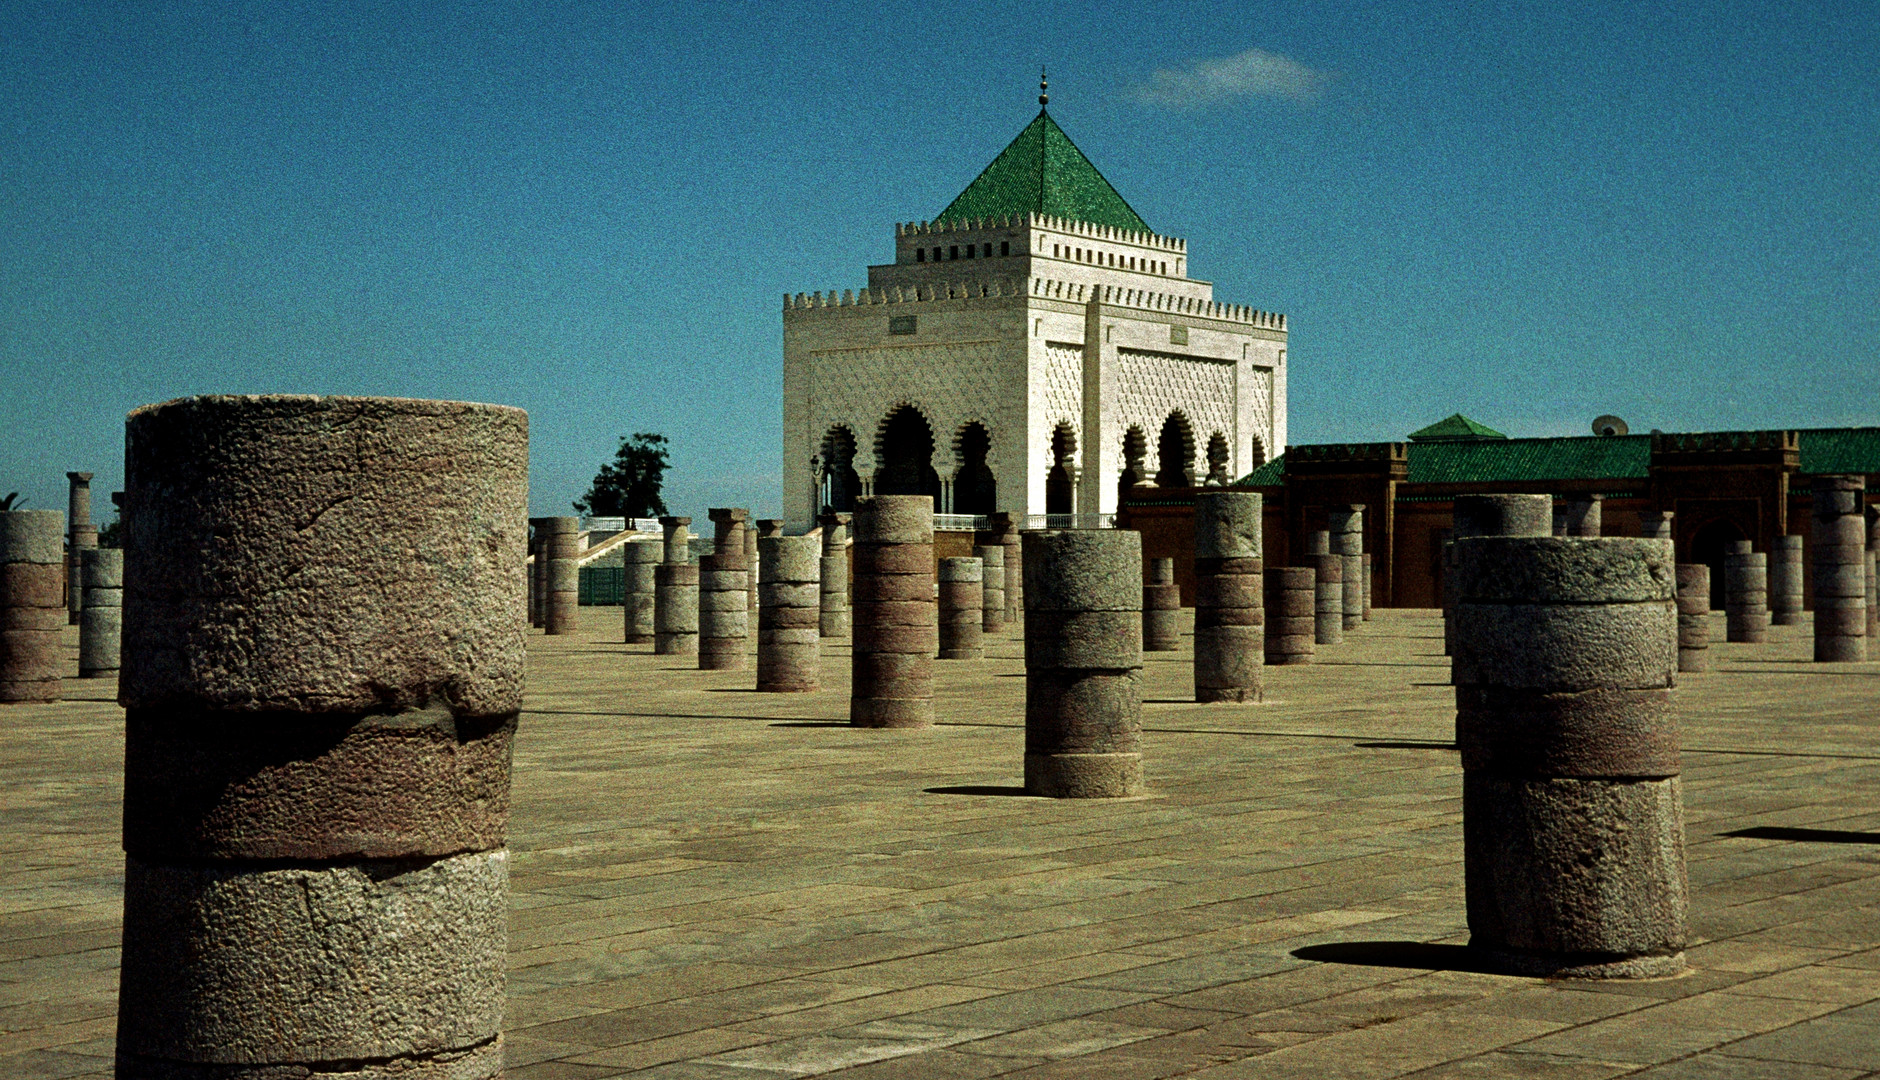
(0, 608, 1880, 1080)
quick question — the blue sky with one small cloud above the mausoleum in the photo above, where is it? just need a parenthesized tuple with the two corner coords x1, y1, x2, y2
(0, 0, 1880, 517)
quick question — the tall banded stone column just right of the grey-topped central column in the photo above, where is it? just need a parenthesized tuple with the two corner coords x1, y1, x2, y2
(1188, 491, 1263, 702)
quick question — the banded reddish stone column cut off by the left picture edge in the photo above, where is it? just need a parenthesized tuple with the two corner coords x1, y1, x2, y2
(0, 510, 68, 702)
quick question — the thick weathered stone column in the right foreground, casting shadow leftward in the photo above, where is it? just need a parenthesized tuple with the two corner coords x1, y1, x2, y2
(1455, 536, 1688, 978)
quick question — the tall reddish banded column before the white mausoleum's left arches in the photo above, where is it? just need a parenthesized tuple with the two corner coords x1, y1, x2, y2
(848, 495, 940, 728)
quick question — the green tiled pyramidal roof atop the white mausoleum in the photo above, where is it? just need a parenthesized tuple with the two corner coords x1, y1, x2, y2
(934, 109, 1154, 233)
